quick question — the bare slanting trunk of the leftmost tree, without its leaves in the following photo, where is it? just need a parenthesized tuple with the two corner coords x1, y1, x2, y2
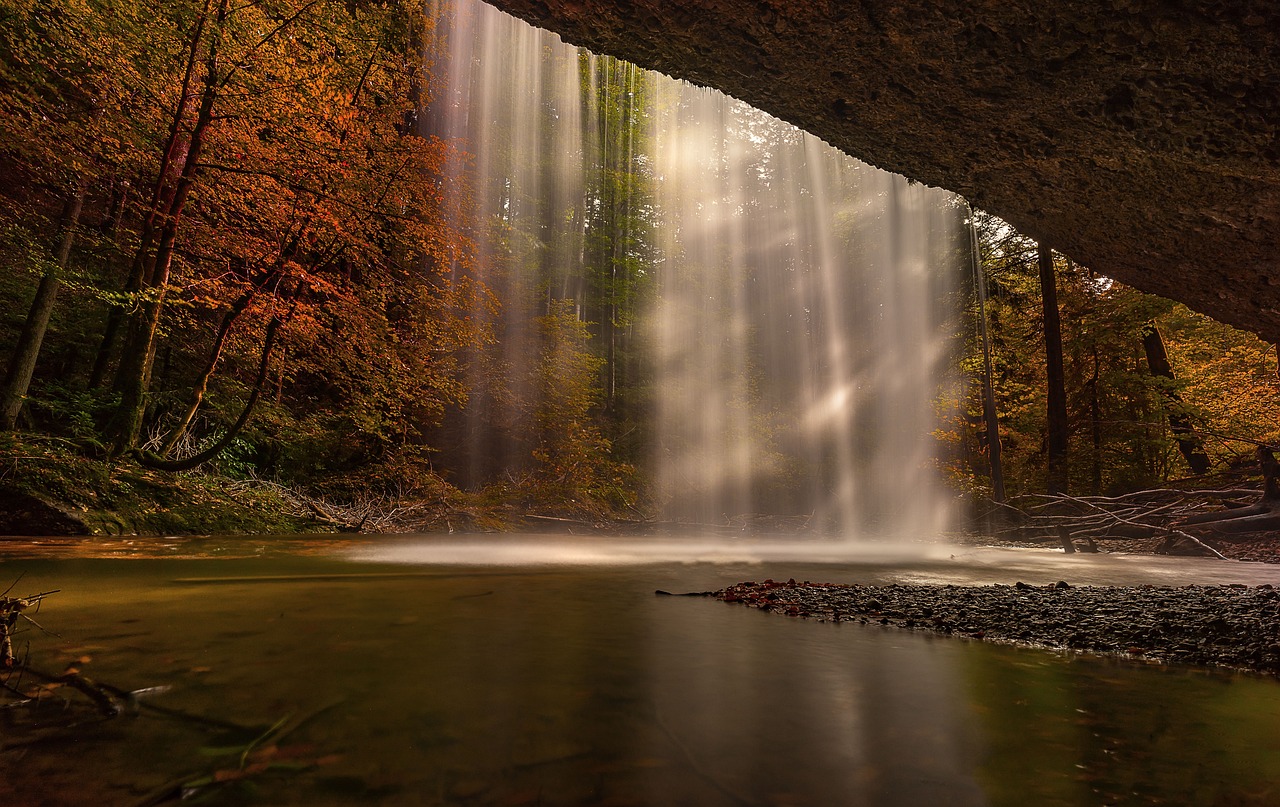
(0, 178, 88, 432)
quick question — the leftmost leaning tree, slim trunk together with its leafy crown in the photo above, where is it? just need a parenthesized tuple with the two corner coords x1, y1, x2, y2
(0, 1, 162, 429)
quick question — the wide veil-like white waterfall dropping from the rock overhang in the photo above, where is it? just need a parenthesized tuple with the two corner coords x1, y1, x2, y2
(429, 0, 964, 537)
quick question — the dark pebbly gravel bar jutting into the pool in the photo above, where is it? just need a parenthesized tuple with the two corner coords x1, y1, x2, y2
(710, 580, 1280, 675)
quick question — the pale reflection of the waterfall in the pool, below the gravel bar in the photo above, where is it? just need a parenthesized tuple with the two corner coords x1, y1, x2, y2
(650, 603, 986, 804)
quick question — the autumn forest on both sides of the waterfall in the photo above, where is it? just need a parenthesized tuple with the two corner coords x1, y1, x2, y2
(0, 0, 1280, 532)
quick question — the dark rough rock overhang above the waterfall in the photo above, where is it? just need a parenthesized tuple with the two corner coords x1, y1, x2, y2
(490, 0, 1280, 341)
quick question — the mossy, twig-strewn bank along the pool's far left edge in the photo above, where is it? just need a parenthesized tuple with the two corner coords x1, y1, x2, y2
(0, 434, 635, 535)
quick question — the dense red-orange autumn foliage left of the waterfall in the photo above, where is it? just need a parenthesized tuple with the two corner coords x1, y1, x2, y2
(0, 0, 489, 486)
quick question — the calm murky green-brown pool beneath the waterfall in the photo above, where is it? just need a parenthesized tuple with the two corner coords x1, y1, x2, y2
(0, 537, 1280, 807)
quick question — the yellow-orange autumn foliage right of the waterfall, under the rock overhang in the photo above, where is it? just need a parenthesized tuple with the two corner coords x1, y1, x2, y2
(940, 213, 1280, 494)
